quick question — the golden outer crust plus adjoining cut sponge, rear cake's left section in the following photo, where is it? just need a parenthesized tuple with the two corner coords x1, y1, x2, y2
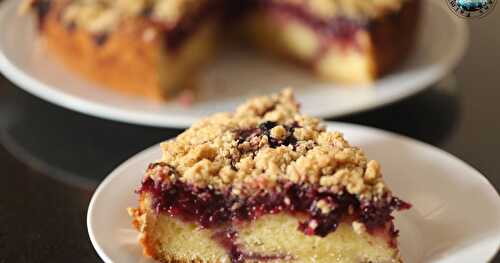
(30, 0, 216, 100)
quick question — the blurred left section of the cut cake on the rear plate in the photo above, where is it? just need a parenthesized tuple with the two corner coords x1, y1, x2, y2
(22, 0, 219, 99)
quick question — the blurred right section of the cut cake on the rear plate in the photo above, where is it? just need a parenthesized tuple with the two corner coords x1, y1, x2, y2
(240, 0, 420, 84)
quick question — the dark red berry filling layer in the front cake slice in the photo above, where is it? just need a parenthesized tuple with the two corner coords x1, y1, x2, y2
(139, 163, 410, 236)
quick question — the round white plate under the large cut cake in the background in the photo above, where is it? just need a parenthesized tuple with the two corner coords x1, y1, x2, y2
(0, 0, 468, 128)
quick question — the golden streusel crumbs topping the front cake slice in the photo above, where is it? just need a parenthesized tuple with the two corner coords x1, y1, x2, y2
(147, 89, 388, 207)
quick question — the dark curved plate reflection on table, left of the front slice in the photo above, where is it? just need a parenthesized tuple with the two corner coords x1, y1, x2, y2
(0, 87, 180, 187)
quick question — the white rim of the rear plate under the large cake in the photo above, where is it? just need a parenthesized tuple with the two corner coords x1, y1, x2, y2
(0, 0, 469, 128)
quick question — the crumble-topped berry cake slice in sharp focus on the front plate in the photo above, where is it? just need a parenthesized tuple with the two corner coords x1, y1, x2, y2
(129, 90, 410, 263)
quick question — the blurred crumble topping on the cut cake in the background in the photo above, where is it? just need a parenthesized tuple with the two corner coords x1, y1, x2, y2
(20, 0, 415, 33)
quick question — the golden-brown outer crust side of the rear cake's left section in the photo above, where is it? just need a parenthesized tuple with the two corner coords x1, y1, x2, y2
(41, 1, 163, 99)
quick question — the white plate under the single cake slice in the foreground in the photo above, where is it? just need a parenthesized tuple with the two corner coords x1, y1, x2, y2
(87, 123, 500, 263)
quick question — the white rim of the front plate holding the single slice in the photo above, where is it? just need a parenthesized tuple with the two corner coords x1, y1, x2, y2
(86, 121, 500, 263)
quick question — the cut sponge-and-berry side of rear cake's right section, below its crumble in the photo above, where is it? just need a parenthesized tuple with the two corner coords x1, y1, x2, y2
(243, 1, 421, 86)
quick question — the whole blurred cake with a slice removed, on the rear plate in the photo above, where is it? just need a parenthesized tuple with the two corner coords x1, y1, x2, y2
(21, 0, 420, 99)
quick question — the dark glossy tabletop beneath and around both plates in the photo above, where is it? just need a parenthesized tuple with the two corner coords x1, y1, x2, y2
(0, 3, 500, 263)
